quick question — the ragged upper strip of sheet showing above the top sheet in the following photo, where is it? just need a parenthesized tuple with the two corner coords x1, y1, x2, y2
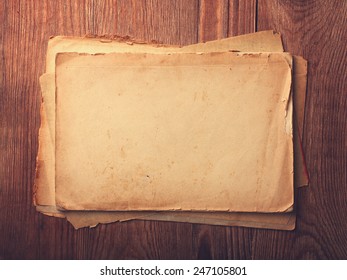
(46, 30, 283, 73)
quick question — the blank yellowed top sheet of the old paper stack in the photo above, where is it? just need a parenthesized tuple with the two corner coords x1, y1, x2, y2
(55, 50, 293, 212)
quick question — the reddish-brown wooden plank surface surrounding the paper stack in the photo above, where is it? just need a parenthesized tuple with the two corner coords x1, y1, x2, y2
(0, 0, 347, 259)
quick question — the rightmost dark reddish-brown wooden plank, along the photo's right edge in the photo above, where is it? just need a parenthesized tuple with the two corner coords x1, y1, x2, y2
(254, 0, 347, 259)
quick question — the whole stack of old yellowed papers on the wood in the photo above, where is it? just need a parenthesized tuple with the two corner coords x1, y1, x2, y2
(34, 31, 308, 230)
